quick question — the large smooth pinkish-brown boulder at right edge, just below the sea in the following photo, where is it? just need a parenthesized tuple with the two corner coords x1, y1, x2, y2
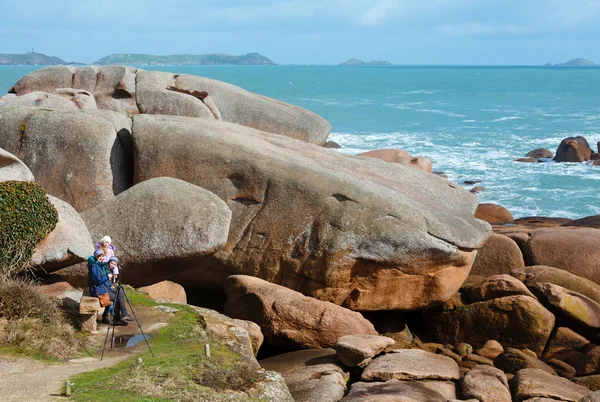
(524, 229, 600, 284)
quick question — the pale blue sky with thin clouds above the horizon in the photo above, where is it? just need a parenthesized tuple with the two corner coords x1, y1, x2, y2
(0, 0, 600, 65)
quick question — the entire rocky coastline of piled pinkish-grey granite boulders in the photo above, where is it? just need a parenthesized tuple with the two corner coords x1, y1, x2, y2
(0, 66, 600, 402)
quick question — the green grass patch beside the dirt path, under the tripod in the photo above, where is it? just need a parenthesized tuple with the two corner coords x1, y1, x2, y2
(71, 289, 259, 402)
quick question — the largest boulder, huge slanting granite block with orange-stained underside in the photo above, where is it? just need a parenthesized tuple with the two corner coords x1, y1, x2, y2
(133, 115, 490, 310)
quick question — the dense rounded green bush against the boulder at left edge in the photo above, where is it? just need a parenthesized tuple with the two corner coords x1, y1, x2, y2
(0, 181, 58, 274)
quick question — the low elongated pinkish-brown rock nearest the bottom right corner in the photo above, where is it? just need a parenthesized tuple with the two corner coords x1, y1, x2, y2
(511, 369, 590, 402)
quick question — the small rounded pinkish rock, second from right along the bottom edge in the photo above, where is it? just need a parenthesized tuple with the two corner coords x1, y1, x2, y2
(460, 365, 512, 402)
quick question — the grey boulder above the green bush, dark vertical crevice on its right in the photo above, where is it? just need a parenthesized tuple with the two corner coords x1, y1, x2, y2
(0, 107, 132, 212)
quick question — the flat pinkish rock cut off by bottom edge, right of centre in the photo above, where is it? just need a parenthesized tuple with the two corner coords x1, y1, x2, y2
(342, 380, 456, 402)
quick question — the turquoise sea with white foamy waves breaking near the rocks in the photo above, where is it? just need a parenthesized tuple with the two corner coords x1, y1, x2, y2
(0, 65, 600, 219)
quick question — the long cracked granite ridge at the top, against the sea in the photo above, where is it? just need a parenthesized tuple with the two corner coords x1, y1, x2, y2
(7, 66, 331, 145)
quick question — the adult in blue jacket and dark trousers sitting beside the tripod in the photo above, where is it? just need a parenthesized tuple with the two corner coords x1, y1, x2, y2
(88, 250, 131, 325)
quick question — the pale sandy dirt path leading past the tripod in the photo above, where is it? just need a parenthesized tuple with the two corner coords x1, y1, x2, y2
(0, 308, 168, 402)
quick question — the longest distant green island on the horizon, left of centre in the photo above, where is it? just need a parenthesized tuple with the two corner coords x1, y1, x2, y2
(93, 53, 277, 65)
